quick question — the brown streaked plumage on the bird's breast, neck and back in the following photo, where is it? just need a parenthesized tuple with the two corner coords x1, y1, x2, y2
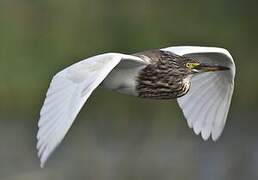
(135, 50, 194, 99)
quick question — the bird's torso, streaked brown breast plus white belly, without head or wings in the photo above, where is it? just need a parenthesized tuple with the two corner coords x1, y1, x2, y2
(103, 49, 191, 99)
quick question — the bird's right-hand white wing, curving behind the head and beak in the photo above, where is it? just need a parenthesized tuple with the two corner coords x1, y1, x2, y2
(163, 46, 235, 140)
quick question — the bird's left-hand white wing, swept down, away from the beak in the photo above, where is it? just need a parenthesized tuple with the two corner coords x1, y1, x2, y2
(37, 53, 141, 167)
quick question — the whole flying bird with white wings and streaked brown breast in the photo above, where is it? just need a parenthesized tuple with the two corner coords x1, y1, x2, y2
(37, 46, 235, 167)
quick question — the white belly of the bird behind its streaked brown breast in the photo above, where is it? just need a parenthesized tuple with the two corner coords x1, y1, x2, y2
(102, 65, 144, 96)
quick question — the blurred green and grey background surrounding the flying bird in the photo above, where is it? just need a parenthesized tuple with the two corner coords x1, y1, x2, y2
(0, 0, 258, 180)
